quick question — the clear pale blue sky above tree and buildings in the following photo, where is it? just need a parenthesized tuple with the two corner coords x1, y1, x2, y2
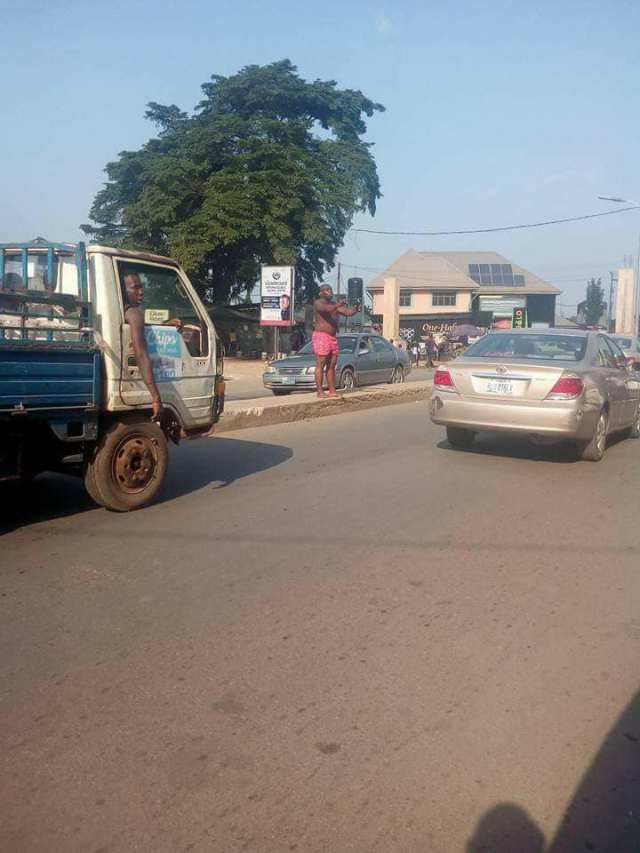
(0, 0, 640, 305)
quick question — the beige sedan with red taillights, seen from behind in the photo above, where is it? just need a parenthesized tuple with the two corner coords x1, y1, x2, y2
(431, 329, 640, 462)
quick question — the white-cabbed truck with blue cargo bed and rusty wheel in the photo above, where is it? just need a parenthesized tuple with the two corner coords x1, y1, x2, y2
(0, 241, 224, 511)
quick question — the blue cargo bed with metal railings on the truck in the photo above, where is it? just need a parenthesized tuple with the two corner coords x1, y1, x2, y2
(0, 241, 101, 414)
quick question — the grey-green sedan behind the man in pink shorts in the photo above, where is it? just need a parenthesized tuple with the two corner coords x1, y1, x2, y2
(263, 332, 411, 396)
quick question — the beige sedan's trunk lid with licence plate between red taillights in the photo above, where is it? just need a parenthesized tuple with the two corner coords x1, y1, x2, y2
(447, 359, 571, 401)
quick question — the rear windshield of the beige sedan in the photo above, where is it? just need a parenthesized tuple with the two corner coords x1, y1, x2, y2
(465, 332, 587, 361)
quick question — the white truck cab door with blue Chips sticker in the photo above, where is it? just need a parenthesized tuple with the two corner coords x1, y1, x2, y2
(115, 258, 215, 428)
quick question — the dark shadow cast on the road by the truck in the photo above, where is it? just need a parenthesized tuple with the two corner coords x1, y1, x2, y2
(0, 437, 293, 535)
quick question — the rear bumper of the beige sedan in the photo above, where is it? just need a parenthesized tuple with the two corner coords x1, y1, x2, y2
(431, 390, 597, 439)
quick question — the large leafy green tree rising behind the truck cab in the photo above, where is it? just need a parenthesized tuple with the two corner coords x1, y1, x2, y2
(82, 60, 384, 301)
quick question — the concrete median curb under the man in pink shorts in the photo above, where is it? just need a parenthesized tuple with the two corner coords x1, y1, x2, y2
(214, 381, 433, 435)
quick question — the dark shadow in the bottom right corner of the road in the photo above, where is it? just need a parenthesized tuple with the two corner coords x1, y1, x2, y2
(467, 693, 640, 853)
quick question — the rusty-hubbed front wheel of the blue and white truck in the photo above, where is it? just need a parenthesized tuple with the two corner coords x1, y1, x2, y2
(91, 421, 169, 512)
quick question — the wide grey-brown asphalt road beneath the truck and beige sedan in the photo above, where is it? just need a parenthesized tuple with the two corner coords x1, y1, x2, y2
(0, 403, 640, 853)
